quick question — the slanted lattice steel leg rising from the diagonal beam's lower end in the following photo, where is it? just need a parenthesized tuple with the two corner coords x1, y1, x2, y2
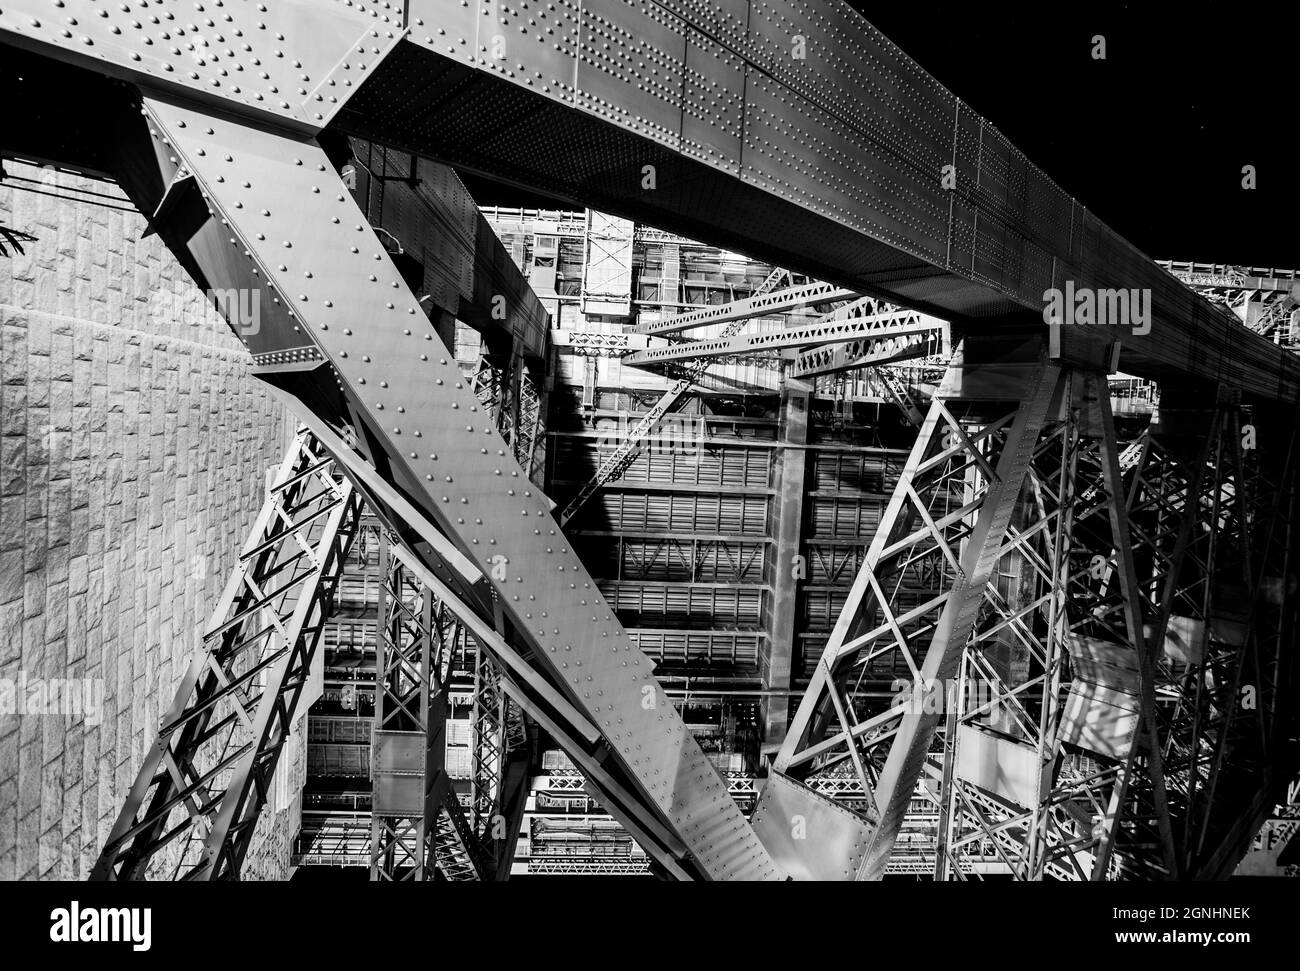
(754, 342, 1140, 879)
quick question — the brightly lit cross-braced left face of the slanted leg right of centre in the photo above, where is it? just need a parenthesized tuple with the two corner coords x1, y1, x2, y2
(775, 356, 1050, 873)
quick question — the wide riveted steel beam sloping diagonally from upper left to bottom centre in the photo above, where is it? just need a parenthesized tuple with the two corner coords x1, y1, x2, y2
(106, 99, 779, 877)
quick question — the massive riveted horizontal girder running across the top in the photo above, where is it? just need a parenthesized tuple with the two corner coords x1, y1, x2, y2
(0, 0, 1300, 400)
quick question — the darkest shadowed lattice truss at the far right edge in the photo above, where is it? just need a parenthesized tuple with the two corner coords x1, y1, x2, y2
(1130, 402, 1296, 879)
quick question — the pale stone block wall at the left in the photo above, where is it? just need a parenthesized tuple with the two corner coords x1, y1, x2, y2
(0, 161, 293, 880)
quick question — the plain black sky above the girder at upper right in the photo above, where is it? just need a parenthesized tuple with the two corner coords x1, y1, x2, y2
(469, 0, 1300, 269)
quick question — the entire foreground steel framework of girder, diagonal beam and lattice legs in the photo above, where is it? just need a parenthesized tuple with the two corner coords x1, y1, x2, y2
(0, 0, 1300, 880)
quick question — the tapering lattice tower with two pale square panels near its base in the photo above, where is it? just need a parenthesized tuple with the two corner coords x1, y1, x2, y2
(936, 372, 1162, 879)
